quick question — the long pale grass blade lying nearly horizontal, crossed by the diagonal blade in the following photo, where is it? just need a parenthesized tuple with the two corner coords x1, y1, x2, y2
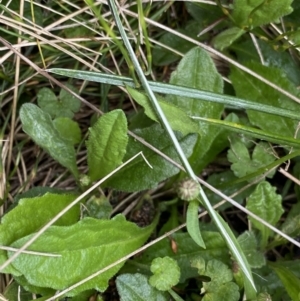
(47, 68, 299, 120)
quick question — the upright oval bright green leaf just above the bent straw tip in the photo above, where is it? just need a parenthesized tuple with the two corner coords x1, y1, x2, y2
(86, 110, 128, 181)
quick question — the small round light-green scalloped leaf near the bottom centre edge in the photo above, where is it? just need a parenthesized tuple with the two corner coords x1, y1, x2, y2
(149, 257, 180, 291)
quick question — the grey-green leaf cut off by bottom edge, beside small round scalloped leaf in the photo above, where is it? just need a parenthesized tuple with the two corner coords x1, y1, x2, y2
(116, 273, 168, 301)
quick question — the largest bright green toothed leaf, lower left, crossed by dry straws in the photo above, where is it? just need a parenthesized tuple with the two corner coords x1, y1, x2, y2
(8, 215, 156, 296)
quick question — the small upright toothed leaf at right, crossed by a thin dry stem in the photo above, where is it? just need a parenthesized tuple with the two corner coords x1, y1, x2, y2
(246, 181, 284, 249)
